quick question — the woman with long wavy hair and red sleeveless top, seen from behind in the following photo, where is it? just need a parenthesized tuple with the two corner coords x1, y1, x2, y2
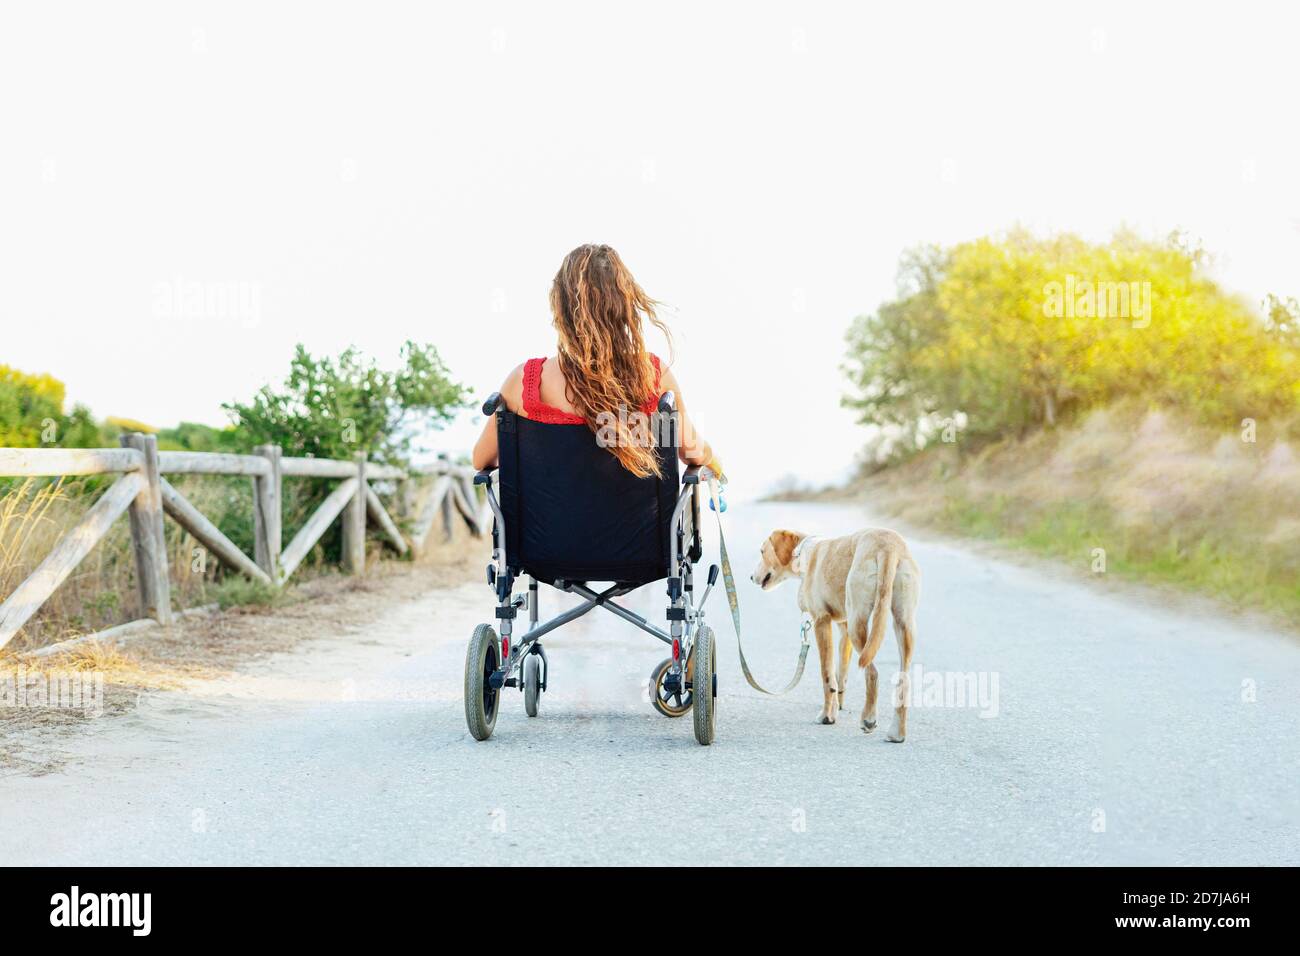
(473, 245, 716, 477)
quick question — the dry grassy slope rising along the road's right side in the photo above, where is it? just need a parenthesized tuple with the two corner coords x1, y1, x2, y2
(850, 408, 1300, 626)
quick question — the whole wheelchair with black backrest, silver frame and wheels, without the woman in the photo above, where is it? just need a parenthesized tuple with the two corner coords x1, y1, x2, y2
(465, 392, 718, 745)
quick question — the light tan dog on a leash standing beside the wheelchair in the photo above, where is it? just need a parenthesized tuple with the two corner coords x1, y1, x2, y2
(750, 528, 920, 744)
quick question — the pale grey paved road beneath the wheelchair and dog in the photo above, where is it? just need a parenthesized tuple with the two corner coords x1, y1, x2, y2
(0, 503, 1300, 865)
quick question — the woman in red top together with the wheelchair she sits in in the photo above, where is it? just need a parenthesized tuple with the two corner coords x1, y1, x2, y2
(465, 245, 720, 744)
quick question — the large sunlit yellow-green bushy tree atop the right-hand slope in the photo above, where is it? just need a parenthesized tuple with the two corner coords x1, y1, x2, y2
(845, 230, 1300, 449)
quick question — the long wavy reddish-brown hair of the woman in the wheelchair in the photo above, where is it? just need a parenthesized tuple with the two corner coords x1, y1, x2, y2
(551, 245, 672, 477)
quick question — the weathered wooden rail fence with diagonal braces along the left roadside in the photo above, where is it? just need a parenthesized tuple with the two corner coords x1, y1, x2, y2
(0, 433, 491, 648)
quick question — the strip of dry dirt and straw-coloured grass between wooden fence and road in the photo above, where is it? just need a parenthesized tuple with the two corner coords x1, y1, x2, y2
(0, 533, 488, 775)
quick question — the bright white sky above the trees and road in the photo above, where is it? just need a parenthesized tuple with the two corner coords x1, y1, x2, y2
(0, 0, 1300, 494)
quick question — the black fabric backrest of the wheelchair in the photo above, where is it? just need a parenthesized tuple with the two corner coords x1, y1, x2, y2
(497, 405, 679, 584)
